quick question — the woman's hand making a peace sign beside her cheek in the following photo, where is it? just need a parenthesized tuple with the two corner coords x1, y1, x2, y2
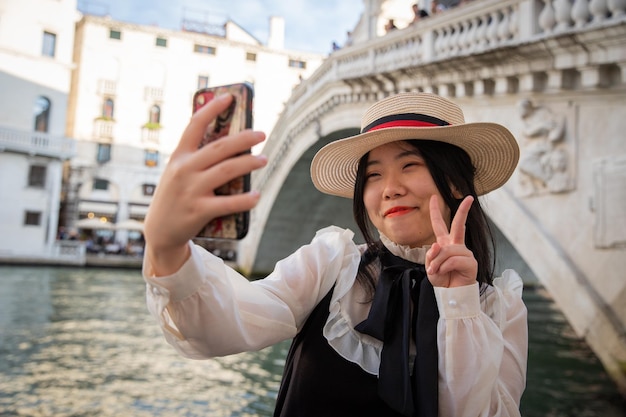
(425, 195, 478, 288)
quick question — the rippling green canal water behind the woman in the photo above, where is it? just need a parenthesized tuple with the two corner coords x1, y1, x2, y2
(0, 266, 626, 417)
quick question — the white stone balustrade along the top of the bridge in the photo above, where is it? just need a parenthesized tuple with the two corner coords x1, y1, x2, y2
(253, 0, 626, 187)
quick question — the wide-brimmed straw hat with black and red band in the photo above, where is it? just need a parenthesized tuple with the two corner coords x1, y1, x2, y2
(311, 93, 519, 198)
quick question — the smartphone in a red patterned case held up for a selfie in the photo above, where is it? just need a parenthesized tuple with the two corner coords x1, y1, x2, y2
(193, 83, 254, 239)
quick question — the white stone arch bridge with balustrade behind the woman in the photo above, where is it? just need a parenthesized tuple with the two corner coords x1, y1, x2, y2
(238, 0, 626, 395)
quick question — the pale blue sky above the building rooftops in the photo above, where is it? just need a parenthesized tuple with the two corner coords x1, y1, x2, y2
(78, 0, 363, 54)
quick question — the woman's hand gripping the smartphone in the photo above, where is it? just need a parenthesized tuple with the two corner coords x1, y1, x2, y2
(144, 94, 267, 275)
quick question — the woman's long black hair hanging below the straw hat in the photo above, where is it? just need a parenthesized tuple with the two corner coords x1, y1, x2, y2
(352, 140, 495, 296)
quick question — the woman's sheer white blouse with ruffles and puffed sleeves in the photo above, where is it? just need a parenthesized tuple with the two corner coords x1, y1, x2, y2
(143, 226, 528, 417)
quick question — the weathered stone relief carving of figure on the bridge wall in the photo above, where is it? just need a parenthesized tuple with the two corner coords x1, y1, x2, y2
(518, 99, 571, 196)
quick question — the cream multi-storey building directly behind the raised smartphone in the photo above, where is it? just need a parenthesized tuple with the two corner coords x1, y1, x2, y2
(61, 15, 323, 247)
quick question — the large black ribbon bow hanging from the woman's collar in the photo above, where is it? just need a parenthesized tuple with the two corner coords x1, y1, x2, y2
(355, 248, 439, 417)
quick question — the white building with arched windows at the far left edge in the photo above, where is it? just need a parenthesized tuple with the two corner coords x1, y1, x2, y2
(0, 0, 77, 257)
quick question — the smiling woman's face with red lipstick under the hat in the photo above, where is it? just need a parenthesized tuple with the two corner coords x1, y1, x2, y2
(363, 141, 450, 248)
